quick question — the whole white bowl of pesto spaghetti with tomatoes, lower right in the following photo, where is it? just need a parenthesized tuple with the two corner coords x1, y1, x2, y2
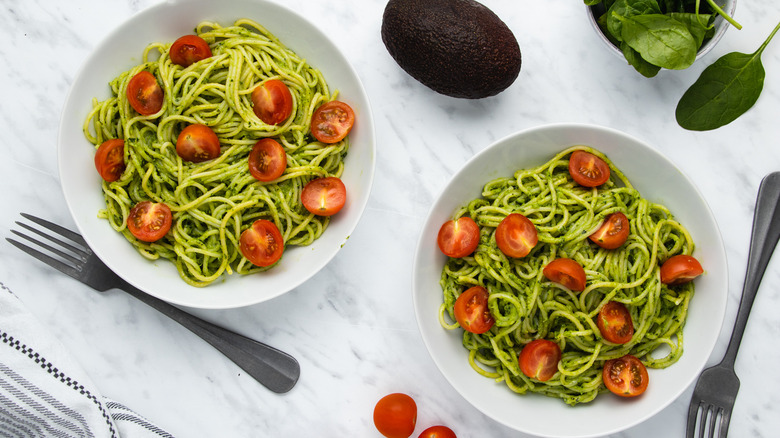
(413, 124, 728, 437)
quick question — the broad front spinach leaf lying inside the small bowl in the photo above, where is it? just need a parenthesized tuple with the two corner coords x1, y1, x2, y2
(617, 14, 699, 70)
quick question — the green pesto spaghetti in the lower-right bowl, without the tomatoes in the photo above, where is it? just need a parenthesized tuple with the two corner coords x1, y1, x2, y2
(440, 146, 694, 405)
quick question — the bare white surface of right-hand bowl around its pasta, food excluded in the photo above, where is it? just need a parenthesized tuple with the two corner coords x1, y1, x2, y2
(412, 124, 728, 437)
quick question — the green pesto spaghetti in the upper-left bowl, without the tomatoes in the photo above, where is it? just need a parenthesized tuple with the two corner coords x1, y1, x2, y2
(84, 19, 349, 286)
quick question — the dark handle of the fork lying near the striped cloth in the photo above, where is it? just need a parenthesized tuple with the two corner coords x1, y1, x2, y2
(121, 281, 301, 393)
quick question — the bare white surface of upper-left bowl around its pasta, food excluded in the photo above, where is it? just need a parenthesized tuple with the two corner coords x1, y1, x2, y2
(58, 0, 376, 309)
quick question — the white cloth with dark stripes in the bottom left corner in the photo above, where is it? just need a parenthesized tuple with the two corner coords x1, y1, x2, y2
(0, 283, 171, 438)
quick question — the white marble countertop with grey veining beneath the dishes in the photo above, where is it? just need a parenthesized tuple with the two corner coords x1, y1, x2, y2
(0, 0, 780, 438)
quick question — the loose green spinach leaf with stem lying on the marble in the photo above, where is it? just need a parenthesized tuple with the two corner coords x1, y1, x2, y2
(675, 23, 780, 131)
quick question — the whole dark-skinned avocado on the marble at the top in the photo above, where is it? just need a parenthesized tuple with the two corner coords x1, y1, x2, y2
(382, 0, 521, 99)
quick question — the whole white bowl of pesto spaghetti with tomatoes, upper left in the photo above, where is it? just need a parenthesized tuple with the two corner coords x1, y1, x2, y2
(59, 0, 375, 309)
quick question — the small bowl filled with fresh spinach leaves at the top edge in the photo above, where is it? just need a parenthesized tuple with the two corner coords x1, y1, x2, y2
(584, 0, 742, 77)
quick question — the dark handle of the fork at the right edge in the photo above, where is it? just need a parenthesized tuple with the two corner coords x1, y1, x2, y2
(722, 172, 780, 366)
